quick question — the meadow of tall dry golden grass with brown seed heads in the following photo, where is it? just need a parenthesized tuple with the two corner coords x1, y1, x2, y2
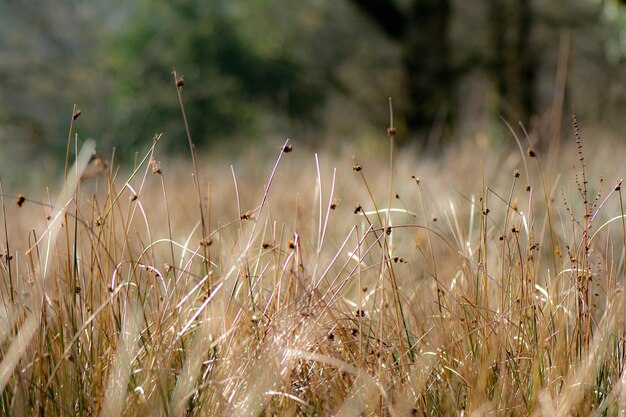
(0, 99, 626, 417)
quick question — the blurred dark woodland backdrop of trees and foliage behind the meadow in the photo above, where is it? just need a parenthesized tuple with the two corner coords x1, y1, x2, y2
(0, 0, 626, 158)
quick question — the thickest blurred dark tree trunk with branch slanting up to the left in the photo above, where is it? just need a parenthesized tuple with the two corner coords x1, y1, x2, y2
(350, 0, 448, 140)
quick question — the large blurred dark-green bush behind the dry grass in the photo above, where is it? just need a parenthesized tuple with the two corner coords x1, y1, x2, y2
(108, 0, 323, 150)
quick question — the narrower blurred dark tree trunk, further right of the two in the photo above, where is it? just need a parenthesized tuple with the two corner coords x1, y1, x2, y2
(488, 0, 537, 127)
